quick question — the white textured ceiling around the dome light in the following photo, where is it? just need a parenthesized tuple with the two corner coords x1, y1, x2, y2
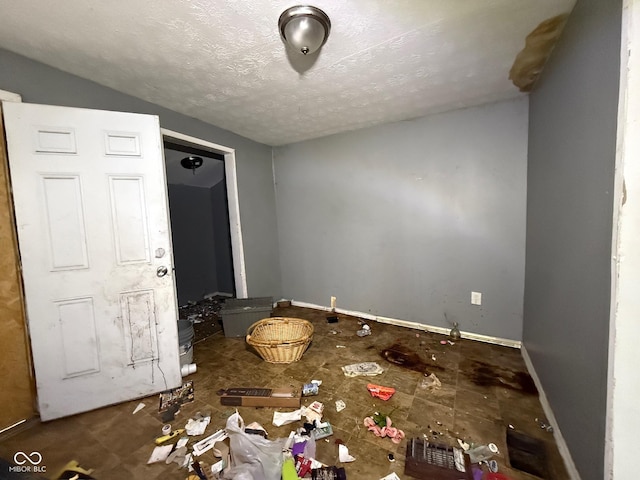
(0, 0, 575, 145)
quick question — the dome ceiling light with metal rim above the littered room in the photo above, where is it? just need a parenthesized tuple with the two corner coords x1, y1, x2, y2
(278, 5, 331, 55)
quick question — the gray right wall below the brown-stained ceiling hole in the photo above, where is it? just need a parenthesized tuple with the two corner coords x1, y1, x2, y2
(523, 0, 622, 480)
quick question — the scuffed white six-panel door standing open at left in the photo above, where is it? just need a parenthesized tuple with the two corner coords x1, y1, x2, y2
(3, 103, 181, 420)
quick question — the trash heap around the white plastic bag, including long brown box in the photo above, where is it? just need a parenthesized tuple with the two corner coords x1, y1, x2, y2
(141, 380, 362, 480)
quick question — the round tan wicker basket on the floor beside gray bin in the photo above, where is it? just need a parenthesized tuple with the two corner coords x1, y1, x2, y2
(247, 317, 313, 363)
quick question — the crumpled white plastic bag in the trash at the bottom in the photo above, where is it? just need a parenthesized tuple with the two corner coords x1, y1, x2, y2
(224, 411, 282, 480)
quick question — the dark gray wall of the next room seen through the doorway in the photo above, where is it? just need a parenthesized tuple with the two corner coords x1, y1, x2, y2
(168, 184, 219, 305)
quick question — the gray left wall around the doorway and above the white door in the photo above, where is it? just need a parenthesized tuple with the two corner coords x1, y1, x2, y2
(0, 49, 281, 298)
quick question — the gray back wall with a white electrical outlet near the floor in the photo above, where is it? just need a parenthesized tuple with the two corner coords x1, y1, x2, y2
(274, 98, 528, 340)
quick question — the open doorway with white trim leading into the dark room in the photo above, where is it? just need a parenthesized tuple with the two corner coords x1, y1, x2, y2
(162, 129, 247, 341)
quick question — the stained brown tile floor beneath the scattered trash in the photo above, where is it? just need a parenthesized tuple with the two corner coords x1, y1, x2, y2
(0, 307, 569, 480)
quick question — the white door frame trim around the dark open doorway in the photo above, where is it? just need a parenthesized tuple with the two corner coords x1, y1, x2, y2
(160, 128, 248, 298)
